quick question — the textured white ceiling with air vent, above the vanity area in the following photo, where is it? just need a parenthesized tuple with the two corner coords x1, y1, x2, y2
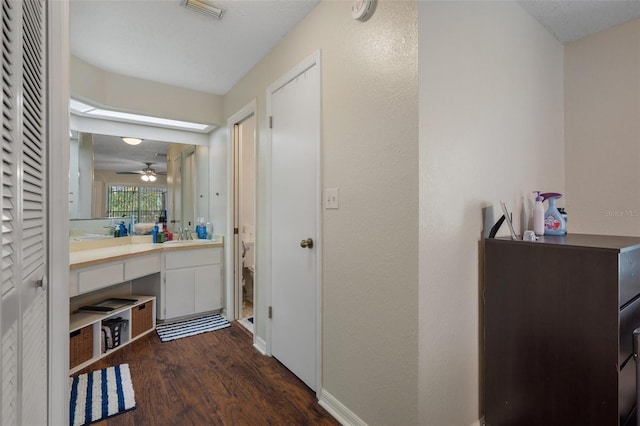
(69, 0, 318, 95)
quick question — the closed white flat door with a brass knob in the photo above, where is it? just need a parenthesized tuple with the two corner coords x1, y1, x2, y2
(271, 55, 321, 390)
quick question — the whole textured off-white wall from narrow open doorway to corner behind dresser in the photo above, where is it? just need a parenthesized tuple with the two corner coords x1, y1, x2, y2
(66, 0, 576, 425)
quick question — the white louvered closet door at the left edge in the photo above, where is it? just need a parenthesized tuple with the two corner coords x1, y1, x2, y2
(0, 0, 48, 425)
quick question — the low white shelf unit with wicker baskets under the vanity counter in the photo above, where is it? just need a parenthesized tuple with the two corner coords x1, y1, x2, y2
(69, 295, 156, 374)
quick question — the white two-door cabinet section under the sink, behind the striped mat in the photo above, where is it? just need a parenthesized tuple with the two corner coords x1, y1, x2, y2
(158, 247, 222, 320)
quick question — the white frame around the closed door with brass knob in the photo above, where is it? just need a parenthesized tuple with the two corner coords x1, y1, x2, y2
(261, 49, 323, 398)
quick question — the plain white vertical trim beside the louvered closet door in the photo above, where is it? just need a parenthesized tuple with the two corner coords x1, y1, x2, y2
(47, 0, 70, 425)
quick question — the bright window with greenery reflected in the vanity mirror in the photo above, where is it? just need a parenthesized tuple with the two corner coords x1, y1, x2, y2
(107, 185, 167, 223)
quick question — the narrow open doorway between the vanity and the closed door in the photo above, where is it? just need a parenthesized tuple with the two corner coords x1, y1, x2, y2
(231, 111, 256, 334)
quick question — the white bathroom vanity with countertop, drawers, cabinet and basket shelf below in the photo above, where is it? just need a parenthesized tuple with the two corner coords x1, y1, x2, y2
(69, 237, 223, 372)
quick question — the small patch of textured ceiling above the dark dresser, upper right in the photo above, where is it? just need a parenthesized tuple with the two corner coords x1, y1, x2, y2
(519, 0, 640, 43)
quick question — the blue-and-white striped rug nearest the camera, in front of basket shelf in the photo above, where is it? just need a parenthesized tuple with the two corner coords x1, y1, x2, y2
(69, 364, 136, 426)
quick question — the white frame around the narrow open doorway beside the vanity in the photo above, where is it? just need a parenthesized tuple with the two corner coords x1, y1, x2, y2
(225, 99, 255, 330)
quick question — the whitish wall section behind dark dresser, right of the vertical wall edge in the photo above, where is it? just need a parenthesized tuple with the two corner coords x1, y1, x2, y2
(418, 1, 564, 426)
